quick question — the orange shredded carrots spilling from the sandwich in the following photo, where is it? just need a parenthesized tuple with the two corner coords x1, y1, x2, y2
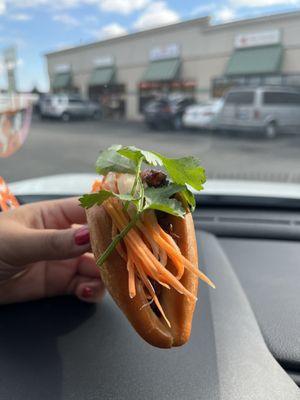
(93, 173, 215, 326)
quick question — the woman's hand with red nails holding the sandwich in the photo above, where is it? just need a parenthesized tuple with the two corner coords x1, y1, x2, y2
(0, 198, 104, 304)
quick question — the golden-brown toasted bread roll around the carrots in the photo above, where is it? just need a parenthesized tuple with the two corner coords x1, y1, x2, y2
(87, 206, 198, 348)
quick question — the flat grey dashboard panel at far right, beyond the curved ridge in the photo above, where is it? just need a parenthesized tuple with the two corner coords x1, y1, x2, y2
(220, 238, 300, 371)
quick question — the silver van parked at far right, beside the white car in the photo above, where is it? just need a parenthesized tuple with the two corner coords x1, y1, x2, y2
(216, 86, 300, 138)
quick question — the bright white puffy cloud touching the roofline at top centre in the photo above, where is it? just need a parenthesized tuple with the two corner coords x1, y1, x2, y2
(133, 1, 180, 30)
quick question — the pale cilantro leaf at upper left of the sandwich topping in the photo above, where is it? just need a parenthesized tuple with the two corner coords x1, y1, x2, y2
(96, 146, 135, 175)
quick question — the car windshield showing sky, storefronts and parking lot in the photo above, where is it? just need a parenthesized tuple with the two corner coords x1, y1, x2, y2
(0, 0, 300, 191)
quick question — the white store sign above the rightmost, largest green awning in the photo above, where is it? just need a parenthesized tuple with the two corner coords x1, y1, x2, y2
(234, 29, 281, 49)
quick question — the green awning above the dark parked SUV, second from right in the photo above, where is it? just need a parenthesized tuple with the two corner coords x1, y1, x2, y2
(143, 58, 180, 82)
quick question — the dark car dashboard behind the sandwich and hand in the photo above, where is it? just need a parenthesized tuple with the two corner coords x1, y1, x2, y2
(0, 196, 300, 400)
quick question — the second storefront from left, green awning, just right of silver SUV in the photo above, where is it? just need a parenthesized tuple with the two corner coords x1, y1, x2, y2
(88, 56, 126, 118)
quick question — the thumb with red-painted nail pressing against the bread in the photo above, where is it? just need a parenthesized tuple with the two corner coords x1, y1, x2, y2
(16, 225, 90, 265)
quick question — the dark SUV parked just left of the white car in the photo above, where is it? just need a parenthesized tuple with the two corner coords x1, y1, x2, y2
(144, 97, 195, 130)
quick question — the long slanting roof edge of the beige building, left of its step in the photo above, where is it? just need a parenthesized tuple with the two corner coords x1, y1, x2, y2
(45, 16, 210, 57)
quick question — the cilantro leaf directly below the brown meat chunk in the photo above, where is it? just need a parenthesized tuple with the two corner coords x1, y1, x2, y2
(143, 184, 186, 218)
